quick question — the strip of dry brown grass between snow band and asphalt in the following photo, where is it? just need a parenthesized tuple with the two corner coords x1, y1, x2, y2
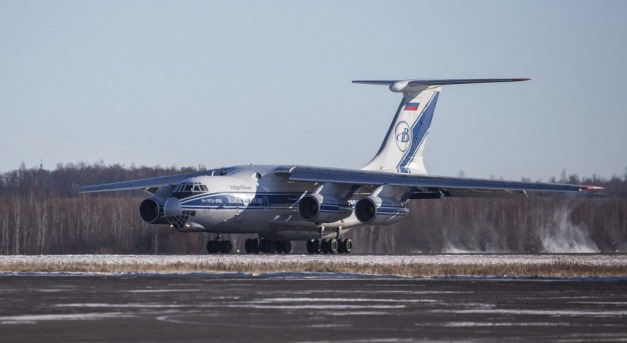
(0, 257, 627, 277)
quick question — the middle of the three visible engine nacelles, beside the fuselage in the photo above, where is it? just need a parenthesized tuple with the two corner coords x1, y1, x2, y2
(298, 194, 353, 223)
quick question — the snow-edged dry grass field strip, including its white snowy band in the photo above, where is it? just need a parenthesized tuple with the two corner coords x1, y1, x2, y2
(0, 254, 627, 277)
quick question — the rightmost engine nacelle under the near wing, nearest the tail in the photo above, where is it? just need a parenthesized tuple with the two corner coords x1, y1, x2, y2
(355, 196, 409, 225)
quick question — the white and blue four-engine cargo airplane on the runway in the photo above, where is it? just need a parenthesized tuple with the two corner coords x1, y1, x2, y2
(80, 78, 602, 254)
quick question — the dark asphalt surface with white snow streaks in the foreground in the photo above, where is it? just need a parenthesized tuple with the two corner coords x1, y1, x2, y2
(0, 274, 627, 342)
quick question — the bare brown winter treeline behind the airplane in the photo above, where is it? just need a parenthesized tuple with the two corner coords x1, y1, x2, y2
(0, 162, 627, 254)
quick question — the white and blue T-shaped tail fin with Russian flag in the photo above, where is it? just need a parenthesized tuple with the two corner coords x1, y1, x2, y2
(353, 78, 531, 174)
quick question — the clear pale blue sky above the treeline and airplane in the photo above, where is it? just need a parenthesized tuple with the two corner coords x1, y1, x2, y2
(0, 0, 627, 180)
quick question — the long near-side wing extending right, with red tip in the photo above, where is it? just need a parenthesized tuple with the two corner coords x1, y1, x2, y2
(275, 166, 603, 199)
